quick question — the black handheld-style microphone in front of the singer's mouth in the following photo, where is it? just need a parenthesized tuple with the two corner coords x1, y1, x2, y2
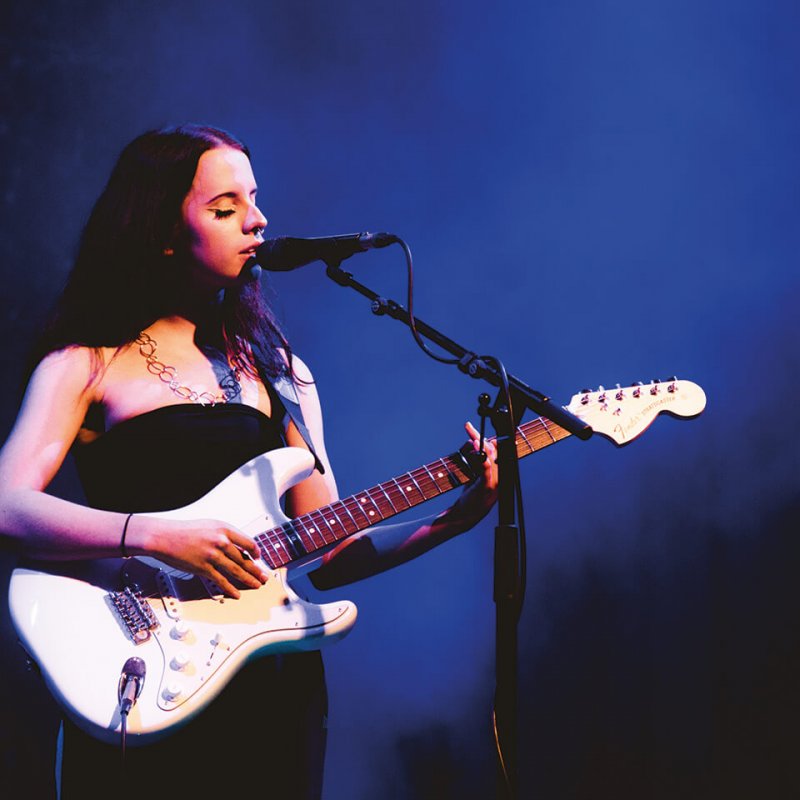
(250, 233, 400, 274)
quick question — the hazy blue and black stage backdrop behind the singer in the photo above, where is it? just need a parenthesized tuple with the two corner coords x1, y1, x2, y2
(0, 0, 800, 800)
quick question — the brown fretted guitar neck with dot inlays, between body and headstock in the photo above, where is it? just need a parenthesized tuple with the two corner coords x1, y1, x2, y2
(255, 417, 571, 569)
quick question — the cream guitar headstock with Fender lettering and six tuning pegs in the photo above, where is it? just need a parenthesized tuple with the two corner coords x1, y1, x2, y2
(566, 378, 706, 446)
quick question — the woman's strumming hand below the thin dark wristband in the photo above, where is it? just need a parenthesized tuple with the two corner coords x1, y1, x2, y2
(131, 514, 267, 598)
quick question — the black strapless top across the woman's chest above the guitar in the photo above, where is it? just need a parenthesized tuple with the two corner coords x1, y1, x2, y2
(74, 403, 285, 513)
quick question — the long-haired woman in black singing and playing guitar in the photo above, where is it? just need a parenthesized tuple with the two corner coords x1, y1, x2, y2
(0, 126, 496, 798)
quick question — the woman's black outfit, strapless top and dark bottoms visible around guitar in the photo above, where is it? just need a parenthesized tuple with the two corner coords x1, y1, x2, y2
(61, 406, 327, 800)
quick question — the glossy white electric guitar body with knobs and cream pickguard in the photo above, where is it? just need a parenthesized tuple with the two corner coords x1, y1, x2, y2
(9, 447, 356, 744)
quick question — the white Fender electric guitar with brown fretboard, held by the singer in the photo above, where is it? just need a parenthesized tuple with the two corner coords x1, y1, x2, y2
(9, 379, 706, 744)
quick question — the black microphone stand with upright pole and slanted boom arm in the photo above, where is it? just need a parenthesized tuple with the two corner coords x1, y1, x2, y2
(326, 259, 592, 800)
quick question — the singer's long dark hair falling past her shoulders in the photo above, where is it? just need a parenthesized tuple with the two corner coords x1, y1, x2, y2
(30, 125, 291, 380)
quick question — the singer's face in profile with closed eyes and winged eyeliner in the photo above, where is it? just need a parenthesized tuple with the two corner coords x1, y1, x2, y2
(182, 147, 267, 289)
